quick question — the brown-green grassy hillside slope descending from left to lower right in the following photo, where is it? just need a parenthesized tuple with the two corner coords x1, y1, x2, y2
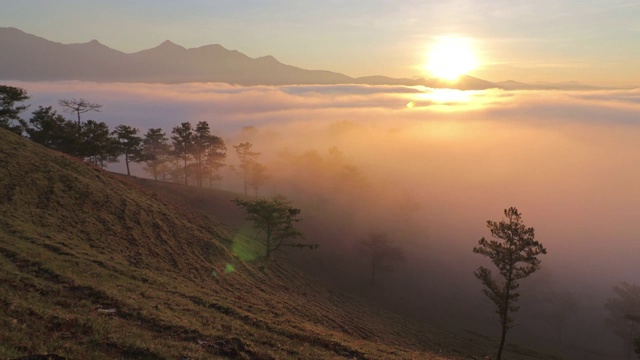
(0, 129, 560, 359)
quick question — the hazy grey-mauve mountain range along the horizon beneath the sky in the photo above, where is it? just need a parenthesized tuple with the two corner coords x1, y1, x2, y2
(0, 27, 594, 90)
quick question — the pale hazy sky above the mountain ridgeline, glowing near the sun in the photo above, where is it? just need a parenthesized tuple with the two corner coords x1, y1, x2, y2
(0, 0, 640, 87)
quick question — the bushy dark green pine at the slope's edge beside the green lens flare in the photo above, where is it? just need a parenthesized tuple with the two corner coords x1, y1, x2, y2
(232, 197, 318, 259)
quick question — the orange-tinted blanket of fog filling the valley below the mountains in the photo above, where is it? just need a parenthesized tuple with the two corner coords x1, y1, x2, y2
(8, 82, 640, 354)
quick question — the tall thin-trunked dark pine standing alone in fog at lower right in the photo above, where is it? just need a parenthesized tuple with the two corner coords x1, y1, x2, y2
(473, 207, 547, 360)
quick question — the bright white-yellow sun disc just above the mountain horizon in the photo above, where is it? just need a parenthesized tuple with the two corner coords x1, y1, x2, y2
(425, 37, 478, 81)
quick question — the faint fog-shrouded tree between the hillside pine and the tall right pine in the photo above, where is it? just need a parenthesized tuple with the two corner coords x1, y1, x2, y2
(358, 233, 404, 285)
